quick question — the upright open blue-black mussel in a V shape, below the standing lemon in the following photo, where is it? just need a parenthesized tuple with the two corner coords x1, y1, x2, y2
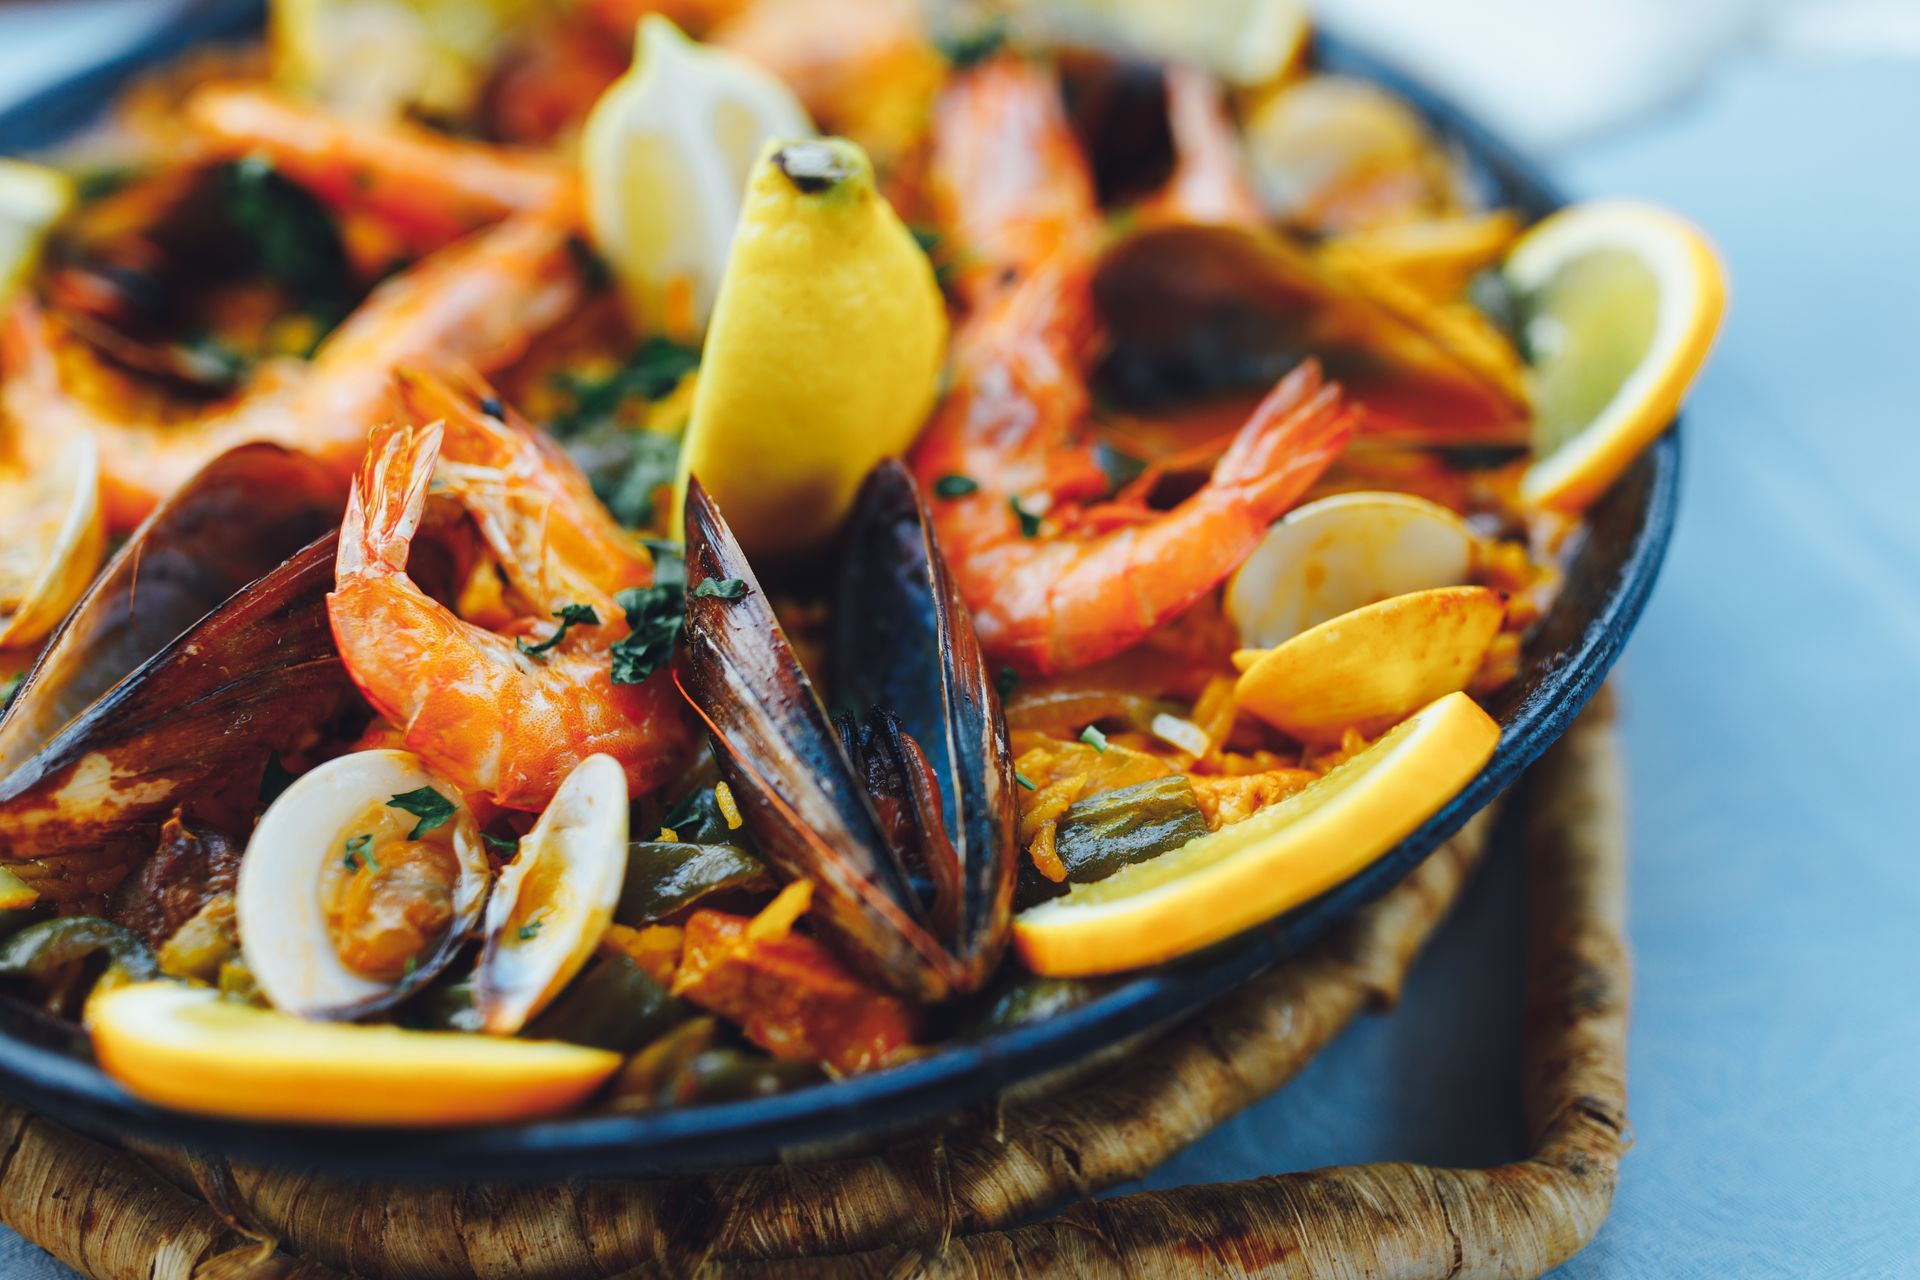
(682, 461, 1016, 1000)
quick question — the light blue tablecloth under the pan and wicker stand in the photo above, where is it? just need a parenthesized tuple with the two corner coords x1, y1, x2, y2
(0, 40, 1920, 1278)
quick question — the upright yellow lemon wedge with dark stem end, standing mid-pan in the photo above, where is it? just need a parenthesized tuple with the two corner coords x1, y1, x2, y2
(676, 138, 947, 555)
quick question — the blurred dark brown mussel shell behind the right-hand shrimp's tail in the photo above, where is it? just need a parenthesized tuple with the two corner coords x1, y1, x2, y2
(1092, 223, 1530, 445)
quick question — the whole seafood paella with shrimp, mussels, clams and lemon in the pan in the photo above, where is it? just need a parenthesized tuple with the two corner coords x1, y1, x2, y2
(0, 0, 1724, 1126)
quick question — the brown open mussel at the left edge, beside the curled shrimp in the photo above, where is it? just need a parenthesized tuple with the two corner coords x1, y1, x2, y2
(0, 443, 349, 904)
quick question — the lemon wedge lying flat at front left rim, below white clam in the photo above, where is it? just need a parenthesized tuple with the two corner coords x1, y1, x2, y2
(86, 983, 620, 1126)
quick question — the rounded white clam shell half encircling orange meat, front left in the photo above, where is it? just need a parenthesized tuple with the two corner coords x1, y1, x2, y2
(234, 750, 490, 1019)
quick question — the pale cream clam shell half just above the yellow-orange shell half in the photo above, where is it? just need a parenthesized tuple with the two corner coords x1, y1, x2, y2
(1227, 491, 1476, 649)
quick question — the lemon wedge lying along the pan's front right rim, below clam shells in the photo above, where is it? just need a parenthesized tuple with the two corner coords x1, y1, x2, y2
(1014, 693, 1500, 977)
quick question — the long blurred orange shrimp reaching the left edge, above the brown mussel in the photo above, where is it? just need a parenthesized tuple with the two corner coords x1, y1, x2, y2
(0, 211, 584, 530)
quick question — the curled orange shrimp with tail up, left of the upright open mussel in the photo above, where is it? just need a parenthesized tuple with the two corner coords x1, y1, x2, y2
(326, 376, 691, 810)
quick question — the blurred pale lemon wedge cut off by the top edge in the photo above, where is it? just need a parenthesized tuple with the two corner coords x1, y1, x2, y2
(1021, 0, 1309, 88)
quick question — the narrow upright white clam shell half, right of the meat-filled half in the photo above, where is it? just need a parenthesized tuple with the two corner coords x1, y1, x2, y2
(474, 756, 628, 1036)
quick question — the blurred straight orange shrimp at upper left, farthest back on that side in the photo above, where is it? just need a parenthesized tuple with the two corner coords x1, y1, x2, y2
(186, 84, 572, 251)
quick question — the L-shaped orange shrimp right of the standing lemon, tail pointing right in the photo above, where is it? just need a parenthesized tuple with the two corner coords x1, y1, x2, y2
(914, 59, 1352, 674)
